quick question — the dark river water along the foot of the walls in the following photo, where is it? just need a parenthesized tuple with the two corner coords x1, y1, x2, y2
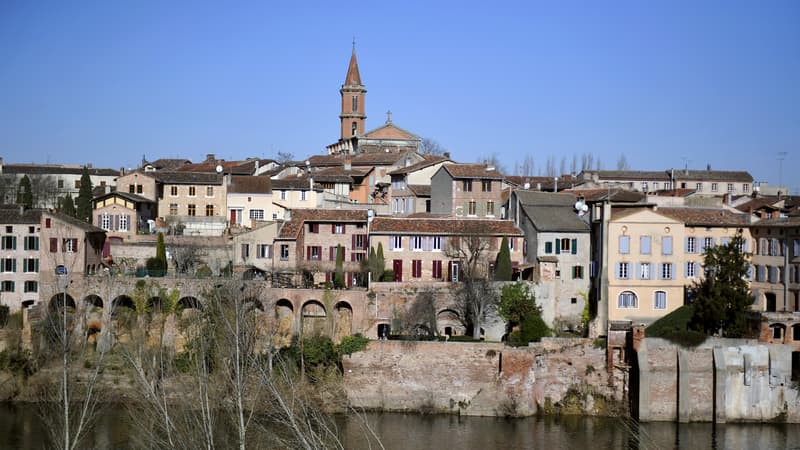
(0, 403, 800, 450)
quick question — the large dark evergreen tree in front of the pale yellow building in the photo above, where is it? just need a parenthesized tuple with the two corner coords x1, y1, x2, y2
(689, 231, 752, 337)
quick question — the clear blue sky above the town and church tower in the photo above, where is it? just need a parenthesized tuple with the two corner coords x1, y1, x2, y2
(0, 0, 800, 193)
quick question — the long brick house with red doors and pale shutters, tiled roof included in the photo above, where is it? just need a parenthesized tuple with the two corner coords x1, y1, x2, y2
(369, 215, 525, 282)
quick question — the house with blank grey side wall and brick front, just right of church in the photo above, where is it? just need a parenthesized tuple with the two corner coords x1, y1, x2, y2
(431, 163, 503, 218)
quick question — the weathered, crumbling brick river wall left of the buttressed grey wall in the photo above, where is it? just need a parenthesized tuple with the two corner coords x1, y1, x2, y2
(343, 339, 625, 416)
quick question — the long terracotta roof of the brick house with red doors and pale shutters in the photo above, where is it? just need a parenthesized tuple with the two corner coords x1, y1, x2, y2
(370, 217, 522, 236)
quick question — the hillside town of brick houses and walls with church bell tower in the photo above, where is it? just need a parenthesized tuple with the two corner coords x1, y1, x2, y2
(0, 43, 800, 446)
